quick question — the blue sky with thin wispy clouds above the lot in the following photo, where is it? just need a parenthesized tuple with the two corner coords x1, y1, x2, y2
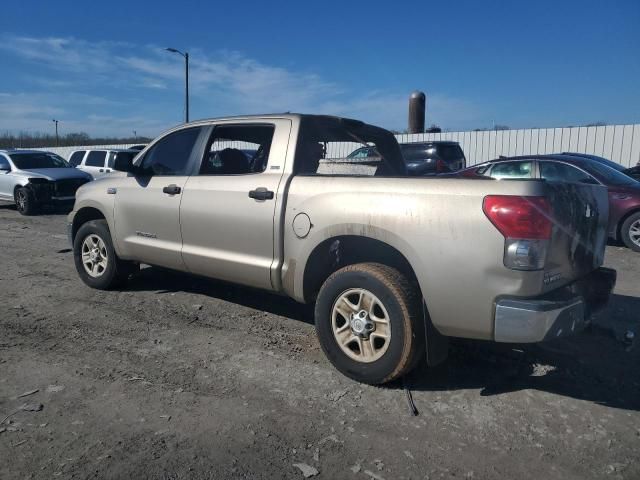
(0, 0, 640, 137)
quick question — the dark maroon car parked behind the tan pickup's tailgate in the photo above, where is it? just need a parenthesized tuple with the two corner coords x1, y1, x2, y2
(457, 153, 640, 252)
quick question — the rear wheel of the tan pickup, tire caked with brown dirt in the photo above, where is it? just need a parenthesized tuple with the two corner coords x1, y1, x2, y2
(315, 263, 424, 385)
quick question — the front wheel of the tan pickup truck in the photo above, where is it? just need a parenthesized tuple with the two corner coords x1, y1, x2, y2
(73, 220, 139, 290)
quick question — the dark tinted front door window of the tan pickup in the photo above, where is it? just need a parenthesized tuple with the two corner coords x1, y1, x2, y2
(140, 127, 202, 176)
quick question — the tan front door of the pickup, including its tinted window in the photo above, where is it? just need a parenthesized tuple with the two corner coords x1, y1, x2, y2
(112, 127, 209, 270)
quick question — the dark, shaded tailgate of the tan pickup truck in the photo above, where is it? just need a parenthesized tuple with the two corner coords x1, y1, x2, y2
(544, 181, 609, 291)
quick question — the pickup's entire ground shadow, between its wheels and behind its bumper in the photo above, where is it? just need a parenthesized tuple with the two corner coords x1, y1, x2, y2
(127, 267, 640, 410)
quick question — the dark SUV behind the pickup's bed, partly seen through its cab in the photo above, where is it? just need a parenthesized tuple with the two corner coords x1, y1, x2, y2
(347, 141, 467, 176)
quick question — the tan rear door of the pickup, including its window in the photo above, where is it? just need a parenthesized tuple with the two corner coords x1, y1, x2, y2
(180, 119, 291, 289)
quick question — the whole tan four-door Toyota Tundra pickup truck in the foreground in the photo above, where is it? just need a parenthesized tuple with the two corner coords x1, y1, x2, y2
(68, 114, 616, 384)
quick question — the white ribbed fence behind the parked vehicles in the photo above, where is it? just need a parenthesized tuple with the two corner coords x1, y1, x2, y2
(43, 124, 640, 167)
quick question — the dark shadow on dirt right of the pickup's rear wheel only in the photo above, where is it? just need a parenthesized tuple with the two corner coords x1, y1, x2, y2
(404, 295, 640, 410)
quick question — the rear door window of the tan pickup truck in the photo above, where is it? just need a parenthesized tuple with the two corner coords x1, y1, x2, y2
(200, 125, 274, 175)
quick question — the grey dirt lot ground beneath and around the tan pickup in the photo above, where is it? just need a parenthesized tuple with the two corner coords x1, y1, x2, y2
(0, 206, 640, 480)
